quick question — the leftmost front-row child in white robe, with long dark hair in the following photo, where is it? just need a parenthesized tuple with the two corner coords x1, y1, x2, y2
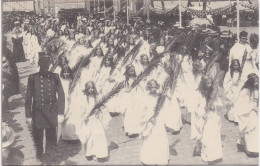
(77, 82, 110, 161)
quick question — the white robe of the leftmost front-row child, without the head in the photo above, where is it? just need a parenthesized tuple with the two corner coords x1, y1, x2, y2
(77, 96, 110, 158)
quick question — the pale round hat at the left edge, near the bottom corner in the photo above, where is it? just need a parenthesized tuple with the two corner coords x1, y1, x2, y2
(2, 123, 15, 148)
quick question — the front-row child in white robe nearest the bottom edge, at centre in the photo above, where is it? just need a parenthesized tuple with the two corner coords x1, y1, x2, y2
(139, 80, 170, 165)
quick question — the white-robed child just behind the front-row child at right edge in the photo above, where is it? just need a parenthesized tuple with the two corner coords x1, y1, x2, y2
(223, 59, 244, 122)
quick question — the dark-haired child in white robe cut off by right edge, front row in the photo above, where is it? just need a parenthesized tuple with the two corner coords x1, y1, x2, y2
(234, 73, 259, 157)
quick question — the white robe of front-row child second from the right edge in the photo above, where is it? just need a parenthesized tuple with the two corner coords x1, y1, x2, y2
(191, 91, 222, 162)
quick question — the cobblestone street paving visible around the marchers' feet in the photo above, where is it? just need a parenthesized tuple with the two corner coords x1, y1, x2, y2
(2, 59, 258, 165)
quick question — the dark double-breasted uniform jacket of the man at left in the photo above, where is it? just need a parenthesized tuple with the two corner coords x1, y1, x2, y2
(25, 72, 65, 129)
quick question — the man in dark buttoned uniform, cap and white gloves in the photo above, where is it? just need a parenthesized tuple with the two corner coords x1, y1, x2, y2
(25, 52, 65, 160)
